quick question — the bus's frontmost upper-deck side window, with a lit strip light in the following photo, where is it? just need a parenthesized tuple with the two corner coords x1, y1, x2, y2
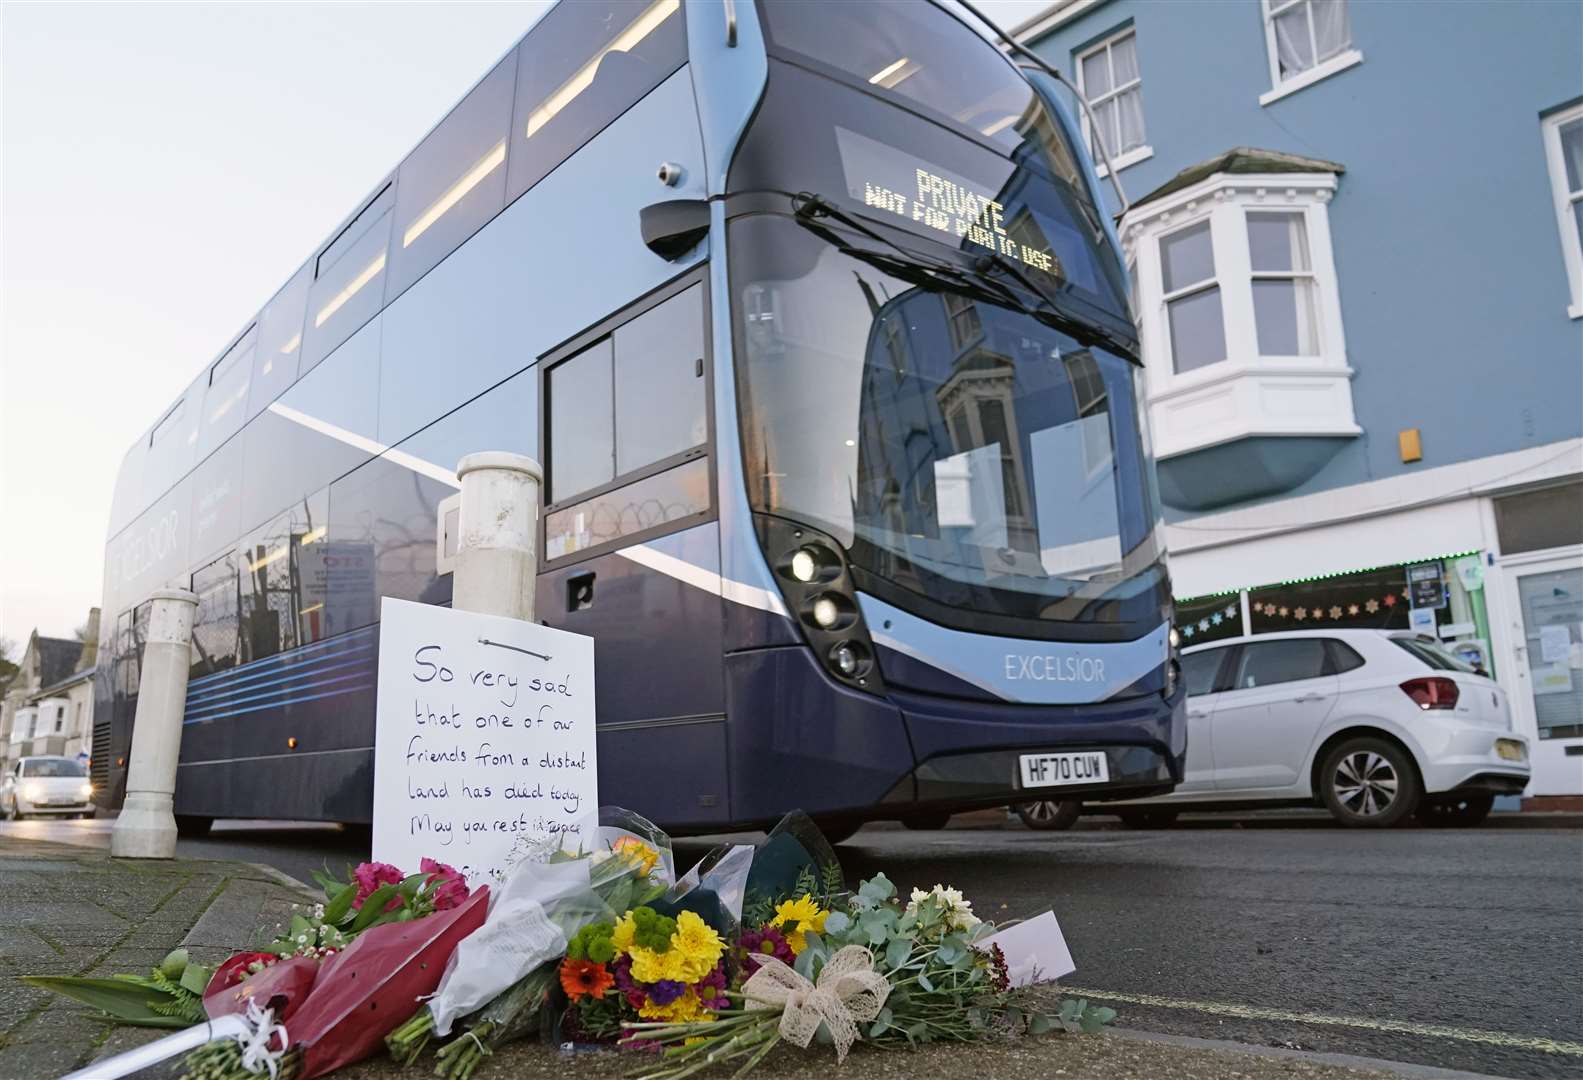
(508, 0, 687, 198)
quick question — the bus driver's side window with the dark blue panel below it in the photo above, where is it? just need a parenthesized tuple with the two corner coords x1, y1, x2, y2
(537, 272, 730, 825)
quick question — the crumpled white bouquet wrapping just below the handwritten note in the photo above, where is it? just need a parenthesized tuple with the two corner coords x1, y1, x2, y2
(429, 858, 613, 1036)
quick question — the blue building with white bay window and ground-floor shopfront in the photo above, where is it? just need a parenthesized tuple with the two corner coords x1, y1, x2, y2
(1016, 0, 1583, 795)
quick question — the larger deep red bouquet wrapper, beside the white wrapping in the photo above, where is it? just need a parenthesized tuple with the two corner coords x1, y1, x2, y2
(291, 887, 489, 1080)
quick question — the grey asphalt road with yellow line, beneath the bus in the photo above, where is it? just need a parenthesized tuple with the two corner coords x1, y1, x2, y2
(0, 817, 1583, 1077)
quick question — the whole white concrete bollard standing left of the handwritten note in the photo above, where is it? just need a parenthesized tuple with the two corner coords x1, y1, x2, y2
(109, 589, 198, 858)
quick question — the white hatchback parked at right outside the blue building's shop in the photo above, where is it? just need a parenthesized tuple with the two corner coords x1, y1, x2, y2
(1024, 630, 1529, 828)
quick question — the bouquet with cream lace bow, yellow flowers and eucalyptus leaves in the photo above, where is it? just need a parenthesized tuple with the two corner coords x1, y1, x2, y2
(622, 874, 1114, 1080)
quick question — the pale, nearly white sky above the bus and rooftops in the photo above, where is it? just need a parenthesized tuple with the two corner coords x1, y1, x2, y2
(0, 0, 1046, 646)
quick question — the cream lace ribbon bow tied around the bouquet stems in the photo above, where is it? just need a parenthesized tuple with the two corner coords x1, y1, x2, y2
(742, 945, 890, 1064)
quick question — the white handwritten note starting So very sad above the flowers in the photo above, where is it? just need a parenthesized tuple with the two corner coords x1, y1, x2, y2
(374, 597, 598, 882)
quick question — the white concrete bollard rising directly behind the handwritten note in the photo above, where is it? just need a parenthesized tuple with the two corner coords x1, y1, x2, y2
(451, 450, 545, 619)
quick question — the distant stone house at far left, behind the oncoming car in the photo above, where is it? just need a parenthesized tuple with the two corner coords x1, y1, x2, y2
(0, 608, 100, 773)
